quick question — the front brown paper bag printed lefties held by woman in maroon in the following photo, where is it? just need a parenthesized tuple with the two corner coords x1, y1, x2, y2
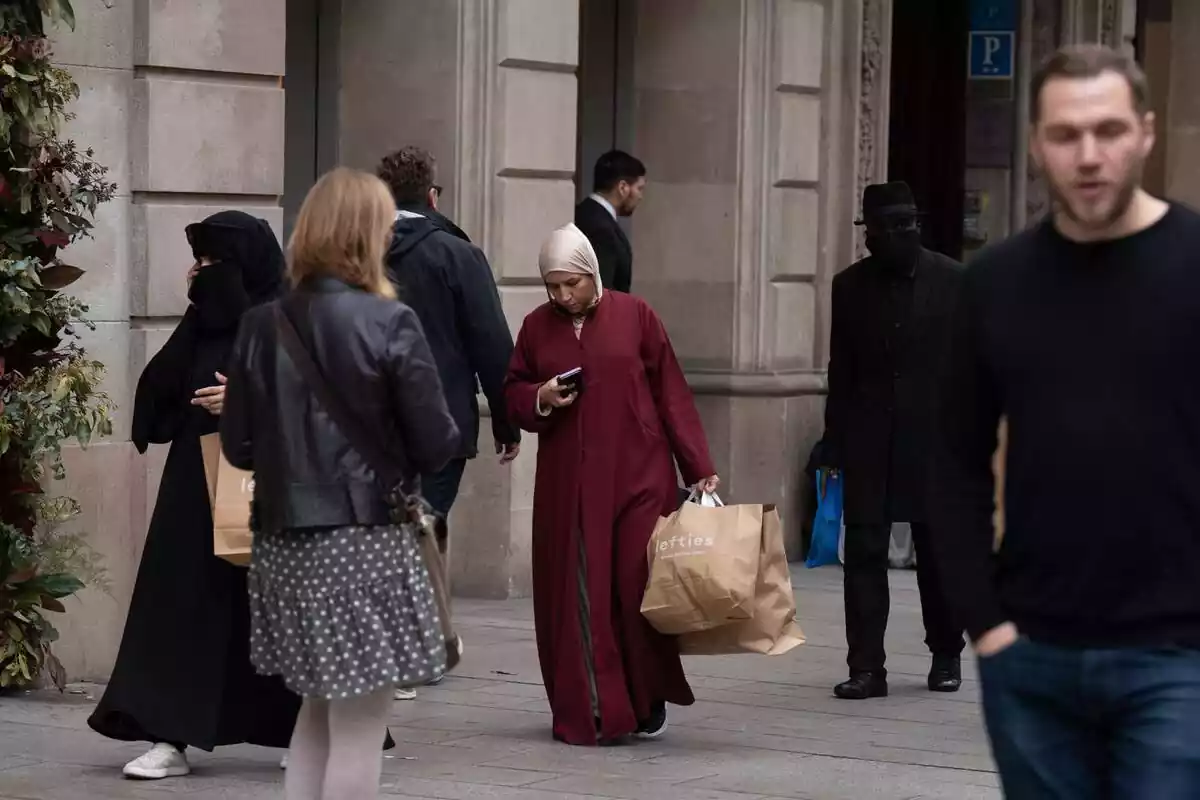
(642, 500, 762, 634)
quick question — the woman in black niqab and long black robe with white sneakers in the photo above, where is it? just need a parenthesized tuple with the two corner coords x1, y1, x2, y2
(88, 211, 300, 780)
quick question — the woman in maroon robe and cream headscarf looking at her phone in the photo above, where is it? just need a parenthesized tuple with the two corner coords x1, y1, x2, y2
(505, 224, 719, 745)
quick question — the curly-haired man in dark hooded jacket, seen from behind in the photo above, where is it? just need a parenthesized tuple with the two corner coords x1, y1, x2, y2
(376, 148, 521, 690)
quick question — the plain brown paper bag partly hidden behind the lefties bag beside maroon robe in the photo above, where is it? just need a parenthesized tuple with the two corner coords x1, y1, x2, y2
(679, 506, 804, 656)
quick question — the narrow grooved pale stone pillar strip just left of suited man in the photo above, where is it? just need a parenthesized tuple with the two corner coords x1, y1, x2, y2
(450, 0, 580, 597)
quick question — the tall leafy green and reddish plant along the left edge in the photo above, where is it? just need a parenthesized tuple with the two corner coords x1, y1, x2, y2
(0, 0, 116, 688)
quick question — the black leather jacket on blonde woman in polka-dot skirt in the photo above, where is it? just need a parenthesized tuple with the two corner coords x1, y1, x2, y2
(221, 278, 460, 531)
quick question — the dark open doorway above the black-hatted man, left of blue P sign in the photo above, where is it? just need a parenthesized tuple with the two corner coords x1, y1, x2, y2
(888, 0, 970, 259)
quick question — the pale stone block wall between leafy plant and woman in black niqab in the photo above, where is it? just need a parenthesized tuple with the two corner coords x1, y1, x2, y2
(50, 0, 286, 678)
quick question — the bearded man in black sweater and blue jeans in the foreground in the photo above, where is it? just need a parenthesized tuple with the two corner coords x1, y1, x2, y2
(934, 46, 1200, 800)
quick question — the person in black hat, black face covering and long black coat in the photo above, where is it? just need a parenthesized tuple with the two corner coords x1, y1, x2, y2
(822, 181, 964, 699)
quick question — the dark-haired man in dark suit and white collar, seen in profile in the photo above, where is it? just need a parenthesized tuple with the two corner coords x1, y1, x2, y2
(575, 150, 646, 293)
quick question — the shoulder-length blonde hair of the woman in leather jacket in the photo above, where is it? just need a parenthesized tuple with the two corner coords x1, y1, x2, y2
(288, 167, 396, 299)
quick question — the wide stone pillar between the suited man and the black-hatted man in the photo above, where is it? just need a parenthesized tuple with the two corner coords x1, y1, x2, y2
(632, 0, 864, 554)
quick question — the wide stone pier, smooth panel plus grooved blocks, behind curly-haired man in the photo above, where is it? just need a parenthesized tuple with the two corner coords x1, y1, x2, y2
(336, 0, 580, 597)
